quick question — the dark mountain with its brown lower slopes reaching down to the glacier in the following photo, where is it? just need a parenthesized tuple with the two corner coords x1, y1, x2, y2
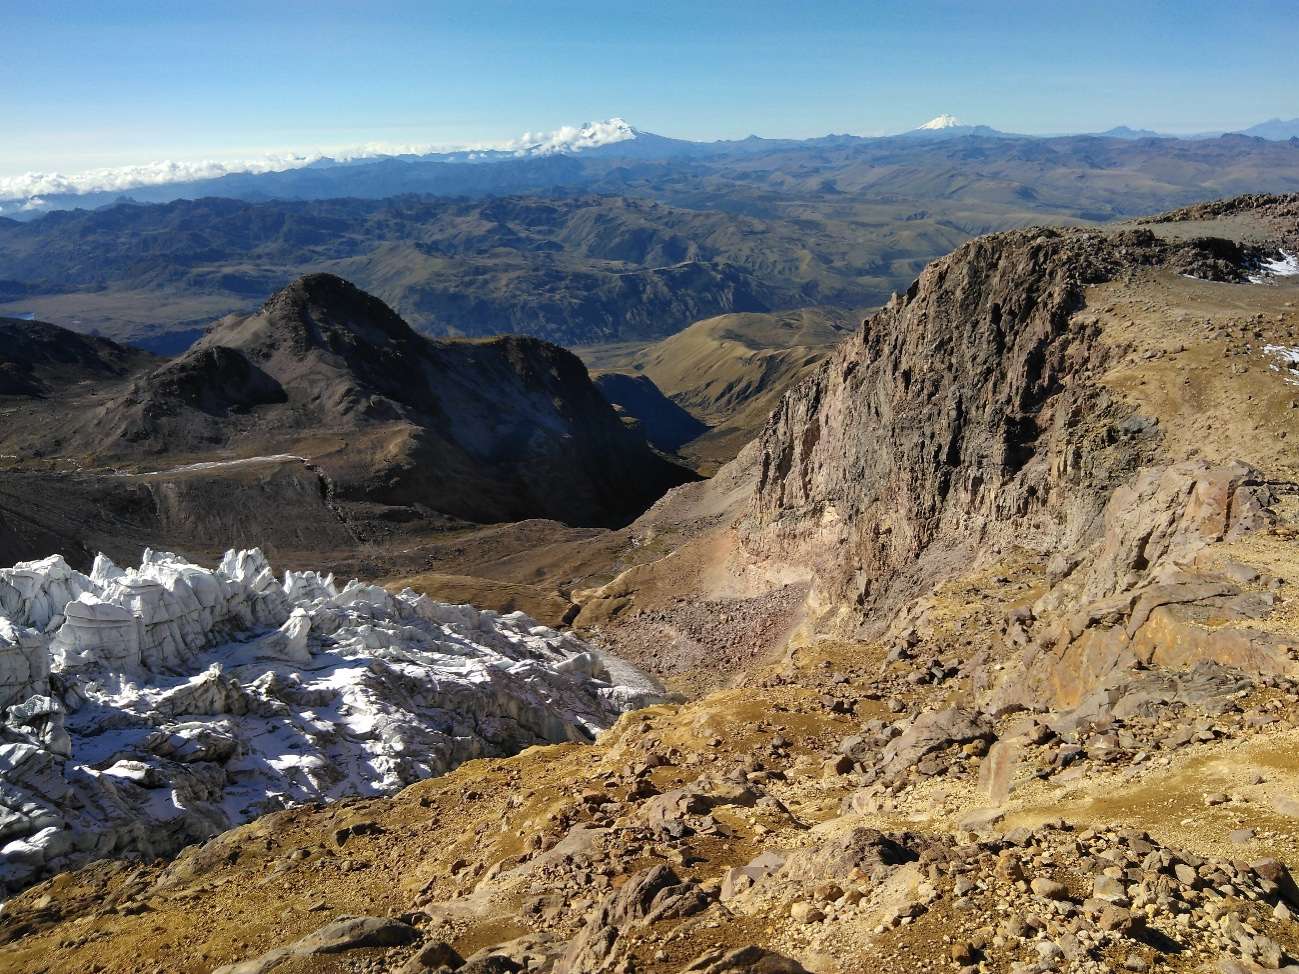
(0, 274, 694, 564)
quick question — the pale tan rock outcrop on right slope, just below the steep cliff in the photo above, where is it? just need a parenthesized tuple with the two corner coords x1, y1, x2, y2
(991, 461, 1299, 709)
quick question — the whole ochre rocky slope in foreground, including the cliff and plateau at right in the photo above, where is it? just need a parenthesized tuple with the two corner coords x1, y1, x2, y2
(0, 197, 1299, 974)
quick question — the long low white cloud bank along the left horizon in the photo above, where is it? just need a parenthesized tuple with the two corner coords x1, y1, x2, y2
(0, 118, 635, 210)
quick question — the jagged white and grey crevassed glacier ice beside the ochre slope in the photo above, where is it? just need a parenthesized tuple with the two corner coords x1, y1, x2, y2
(0, 549, 656, 890)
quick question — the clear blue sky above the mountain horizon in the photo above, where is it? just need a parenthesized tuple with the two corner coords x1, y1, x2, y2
(0, 0, 1299, 175)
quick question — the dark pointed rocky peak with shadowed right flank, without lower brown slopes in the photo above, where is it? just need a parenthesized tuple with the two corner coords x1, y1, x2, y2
(71, 274, 694, 525)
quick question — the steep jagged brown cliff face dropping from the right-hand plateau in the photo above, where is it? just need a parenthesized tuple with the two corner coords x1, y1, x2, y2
(742, 230, 1152, 621)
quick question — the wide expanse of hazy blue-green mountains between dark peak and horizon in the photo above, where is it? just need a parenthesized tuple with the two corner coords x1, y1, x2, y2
(10, 135, 1299, 344)
